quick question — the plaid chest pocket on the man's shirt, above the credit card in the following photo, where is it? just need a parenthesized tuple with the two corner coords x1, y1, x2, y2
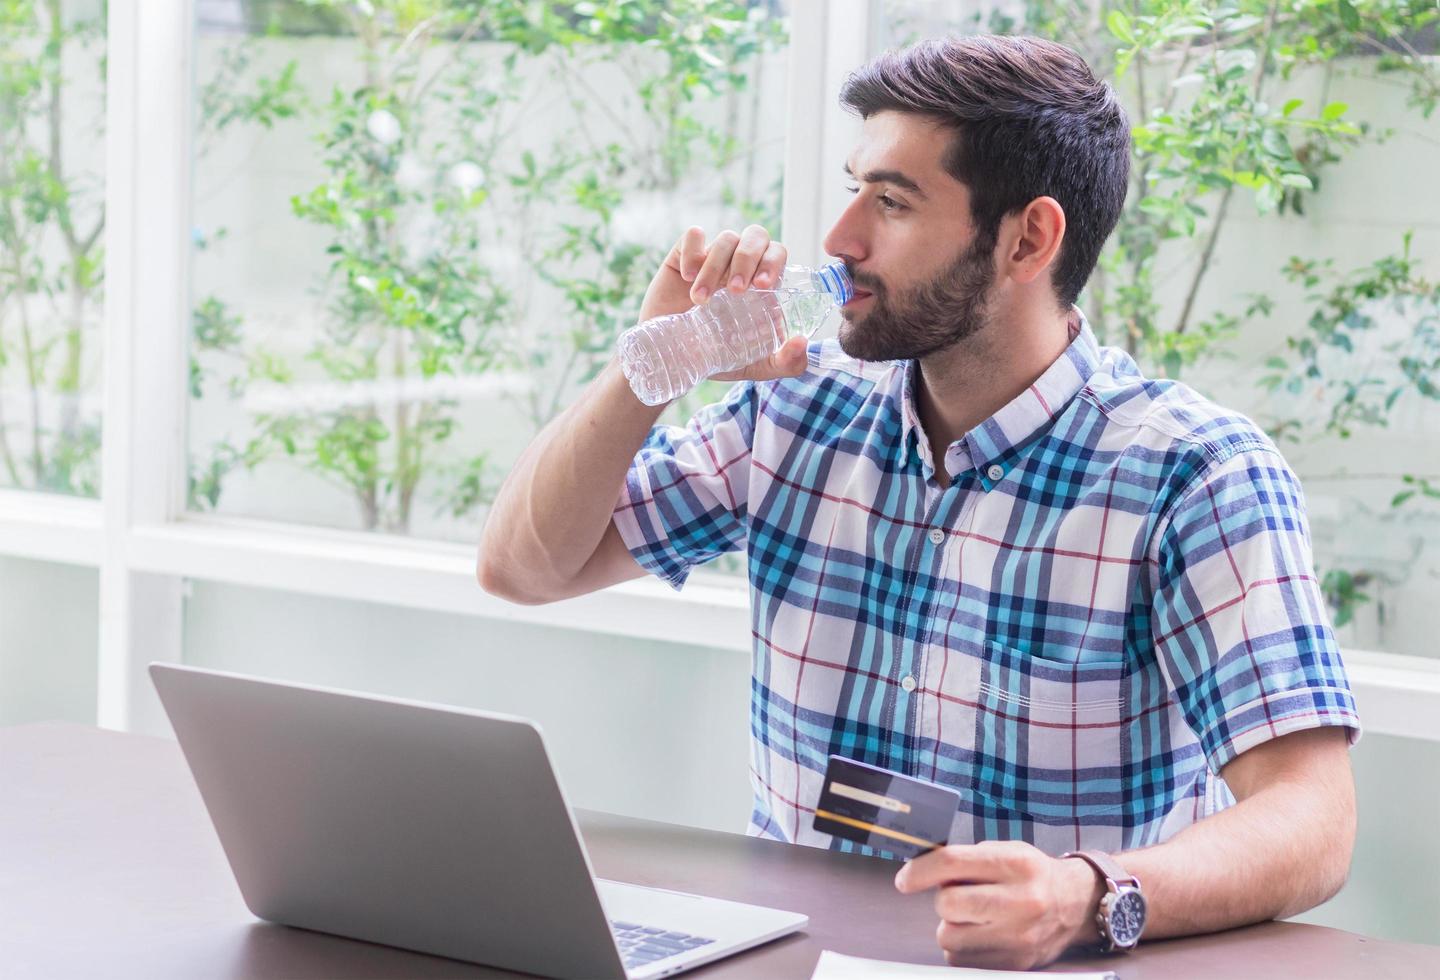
(973, 640, 1126, 826)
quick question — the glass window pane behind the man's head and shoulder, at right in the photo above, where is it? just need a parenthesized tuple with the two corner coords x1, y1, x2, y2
(880, 0, 1440, 656)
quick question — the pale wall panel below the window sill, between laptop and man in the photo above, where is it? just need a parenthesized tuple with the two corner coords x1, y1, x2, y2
(184, 583, 750, 833)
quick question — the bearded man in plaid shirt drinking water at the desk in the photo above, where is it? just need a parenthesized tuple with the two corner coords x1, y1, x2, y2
(478, 37, 1359, 968)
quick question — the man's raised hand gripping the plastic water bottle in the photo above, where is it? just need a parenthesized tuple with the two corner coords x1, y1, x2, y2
(639, 224, 806, 381)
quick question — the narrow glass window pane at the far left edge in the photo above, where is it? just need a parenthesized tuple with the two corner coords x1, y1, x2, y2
(0, 0, 105, 496)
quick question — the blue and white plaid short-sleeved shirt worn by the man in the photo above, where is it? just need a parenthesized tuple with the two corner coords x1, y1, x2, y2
(615, 318, 1359, 853)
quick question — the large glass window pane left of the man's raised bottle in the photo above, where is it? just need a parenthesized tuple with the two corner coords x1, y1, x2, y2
(189, 0, 786, 558)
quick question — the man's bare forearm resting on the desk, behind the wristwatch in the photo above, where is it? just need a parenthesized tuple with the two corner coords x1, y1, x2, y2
(1094, 773, 1355, 938)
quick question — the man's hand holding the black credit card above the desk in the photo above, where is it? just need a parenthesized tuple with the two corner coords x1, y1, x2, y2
(896, 840, 1104, 970)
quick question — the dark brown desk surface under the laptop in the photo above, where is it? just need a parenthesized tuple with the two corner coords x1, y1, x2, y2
(0, 724, 1440, 980)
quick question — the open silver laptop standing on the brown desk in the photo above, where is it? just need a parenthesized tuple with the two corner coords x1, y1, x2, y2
(150, 663, 809, 980)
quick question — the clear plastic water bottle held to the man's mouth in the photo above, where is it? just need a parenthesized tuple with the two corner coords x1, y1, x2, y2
(619, 262, 855, 404)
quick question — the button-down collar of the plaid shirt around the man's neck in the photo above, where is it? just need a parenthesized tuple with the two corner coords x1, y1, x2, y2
(900, 308, 1100, 491)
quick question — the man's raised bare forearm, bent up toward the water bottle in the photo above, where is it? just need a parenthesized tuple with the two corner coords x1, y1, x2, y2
(478, 361, 664, 602)
